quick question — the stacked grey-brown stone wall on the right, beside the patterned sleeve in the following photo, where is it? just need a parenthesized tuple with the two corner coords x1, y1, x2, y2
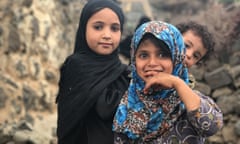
(190, 57, 240, 144)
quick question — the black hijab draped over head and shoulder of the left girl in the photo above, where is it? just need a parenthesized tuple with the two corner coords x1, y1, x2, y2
(56, 0, 126, 140)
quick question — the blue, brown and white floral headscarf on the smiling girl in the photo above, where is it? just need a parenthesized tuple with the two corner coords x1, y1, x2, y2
(113, 21, 188, 141)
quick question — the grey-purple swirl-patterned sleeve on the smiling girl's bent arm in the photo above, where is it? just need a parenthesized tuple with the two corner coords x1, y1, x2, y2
(187, 91, 223, 137)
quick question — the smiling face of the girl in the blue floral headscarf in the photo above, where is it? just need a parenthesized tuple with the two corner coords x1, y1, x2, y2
(135, 40, 173, 81)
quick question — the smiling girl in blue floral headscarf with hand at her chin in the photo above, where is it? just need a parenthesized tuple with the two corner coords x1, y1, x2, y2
(113, 21, 223, 144)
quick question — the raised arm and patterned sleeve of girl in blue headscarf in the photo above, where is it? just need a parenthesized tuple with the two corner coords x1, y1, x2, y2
(144, 73, 223, 137)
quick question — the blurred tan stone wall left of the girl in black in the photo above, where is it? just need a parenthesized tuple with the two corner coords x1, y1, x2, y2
(0, 0, 84, 144)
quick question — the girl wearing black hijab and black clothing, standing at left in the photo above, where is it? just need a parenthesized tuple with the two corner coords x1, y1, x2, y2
(56, 0, 129, 144)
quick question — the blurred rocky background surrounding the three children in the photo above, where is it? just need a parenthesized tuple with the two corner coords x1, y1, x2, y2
(0, 0, 240, 144)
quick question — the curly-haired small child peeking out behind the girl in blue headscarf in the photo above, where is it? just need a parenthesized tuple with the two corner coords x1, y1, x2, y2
(176, 21, 215, 88)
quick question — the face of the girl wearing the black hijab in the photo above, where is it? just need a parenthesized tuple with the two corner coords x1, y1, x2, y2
(86, 8, 121, 55)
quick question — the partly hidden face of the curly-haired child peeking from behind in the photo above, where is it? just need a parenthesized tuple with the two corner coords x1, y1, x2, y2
(183, 30, 207, 68)
